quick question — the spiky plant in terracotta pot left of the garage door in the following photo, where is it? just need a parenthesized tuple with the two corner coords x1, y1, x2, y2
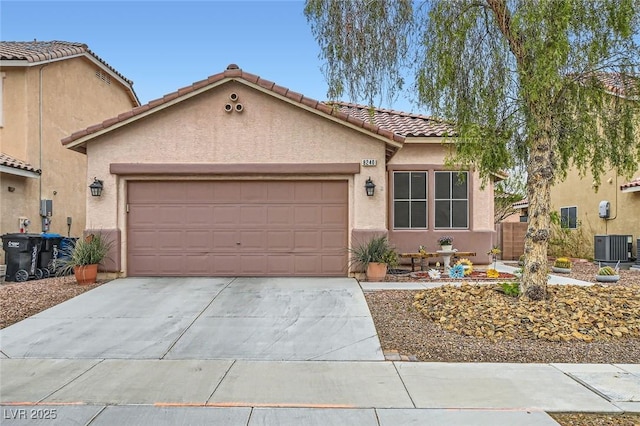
(57, 234, 110, 284)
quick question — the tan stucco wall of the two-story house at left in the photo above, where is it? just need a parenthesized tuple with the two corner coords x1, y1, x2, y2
(0, 57, 135, 243)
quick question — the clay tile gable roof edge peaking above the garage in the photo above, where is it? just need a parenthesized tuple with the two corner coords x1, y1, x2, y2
(62, 64, 408, 155)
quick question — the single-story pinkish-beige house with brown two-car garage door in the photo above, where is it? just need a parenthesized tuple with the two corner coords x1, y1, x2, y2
(62, 64, 495, 276)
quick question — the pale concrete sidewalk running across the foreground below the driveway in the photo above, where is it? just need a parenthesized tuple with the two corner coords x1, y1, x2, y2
(0, 359, 640, 425)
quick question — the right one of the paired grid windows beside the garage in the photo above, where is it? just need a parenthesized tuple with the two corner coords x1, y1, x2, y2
(434, 171, 469, 229)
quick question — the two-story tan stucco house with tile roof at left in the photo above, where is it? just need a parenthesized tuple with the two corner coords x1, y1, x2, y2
(0, 41, 139, 262)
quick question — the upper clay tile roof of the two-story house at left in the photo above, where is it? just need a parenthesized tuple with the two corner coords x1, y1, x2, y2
(0, 40, 133, 85)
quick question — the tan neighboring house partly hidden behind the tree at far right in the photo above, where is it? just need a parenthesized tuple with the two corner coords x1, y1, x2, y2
(551, 74, 640, 256)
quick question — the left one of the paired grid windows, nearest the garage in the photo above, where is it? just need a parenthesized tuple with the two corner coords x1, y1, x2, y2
(393, 172, 427, 229)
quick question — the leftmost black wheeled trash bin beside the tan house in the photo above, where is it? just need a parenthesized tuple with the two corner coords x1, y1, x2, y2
(2, 234, 44, 282)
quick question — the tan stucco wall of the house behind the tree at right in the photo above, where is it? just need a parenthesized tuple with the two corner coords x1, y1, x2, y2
(551, 171, 640, 255)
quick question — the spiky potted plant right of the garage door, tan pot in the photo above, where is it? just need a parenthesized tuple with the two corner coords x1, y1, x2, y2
(351, 236, 398, 281)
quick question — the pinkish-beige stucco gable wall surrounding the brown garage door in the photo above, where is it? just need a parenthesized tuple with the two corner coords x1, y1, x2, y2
(82, 82, 387, 271)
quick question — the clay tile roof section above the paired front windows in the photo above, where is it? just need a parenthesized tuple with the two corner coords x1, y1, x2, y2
(329, 102, 455, 138)
